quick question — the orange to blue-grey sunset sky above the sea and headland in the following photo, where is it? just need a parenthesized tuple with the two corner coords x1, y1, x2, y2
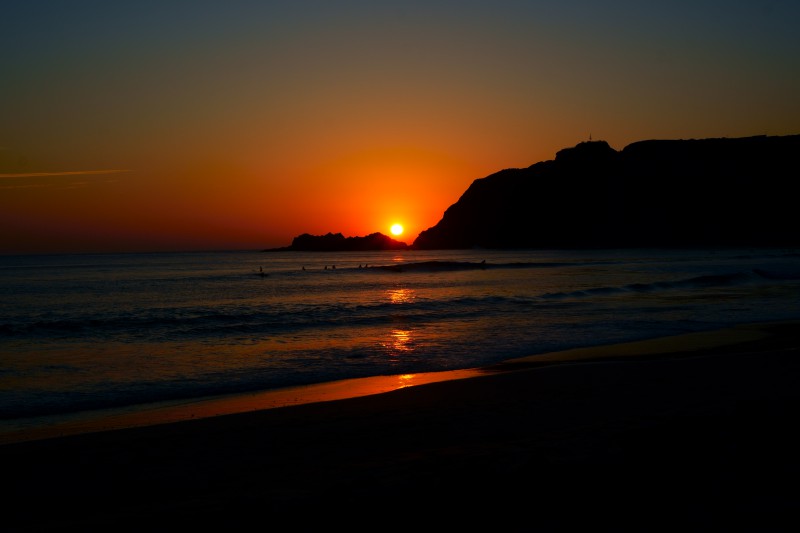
(0, 0, 800, 254)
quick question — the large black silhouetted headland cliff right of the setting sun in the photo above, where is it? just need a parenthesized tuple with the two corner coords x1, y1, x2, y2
(412, 135, 800, 249)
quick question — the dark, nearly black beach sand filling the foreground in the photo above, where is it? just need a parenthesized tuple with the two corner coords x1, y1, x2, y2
(0, 322, 800, 532)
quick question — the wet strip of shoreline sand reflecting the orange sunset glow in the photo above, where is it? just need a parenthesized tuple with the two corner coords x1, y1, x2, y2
(0, 321, 800, 446)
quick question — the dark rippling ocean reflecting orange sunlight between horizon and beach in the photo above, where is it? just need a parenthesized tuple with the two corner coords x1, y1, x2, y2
(0, 245, 800, 432)
